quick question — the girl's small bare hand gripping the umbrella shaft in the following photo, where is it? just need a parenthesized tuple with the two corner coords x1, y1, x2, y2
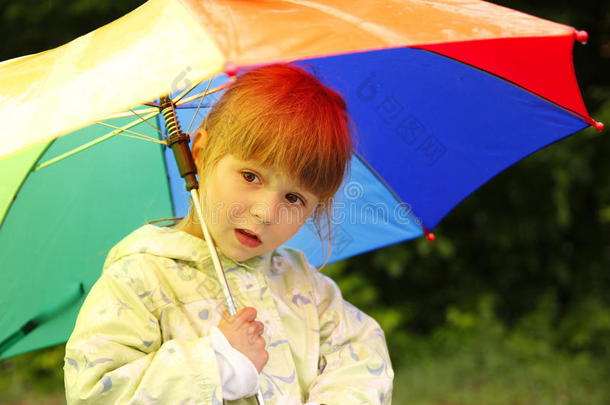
(218, 307, 269, 373)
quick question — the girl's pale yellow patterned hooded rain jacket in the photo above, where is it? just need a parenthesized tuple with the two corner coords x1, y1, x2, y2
(64, 225, 394, 405)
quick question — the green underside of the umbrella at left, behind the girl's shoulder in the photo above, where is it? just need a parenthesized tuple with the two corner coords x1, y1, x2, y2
(0, 113, 174, 359)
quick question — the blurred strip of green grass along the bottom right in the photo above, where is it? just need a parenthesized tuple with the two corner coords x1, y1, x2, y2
(393, 347, 610, 405)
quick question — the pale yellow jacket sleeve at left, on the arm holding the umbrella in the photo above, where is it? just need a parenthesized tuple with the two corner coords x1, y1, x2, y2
(64, 261, 222, 404)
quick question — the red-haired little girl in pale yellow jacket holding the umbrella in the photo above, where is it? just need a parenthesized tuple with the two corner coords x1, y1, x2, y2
(64, 65, 393, 405)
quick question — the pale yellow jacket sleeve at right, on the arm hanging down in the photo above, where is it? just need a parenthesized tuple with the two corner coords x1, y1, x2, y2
(307, 265, 394, 405)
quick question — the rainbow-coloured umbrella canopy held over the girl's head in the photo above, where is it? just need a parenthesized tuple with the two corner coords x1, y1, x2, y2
(0, 0, 602, 357)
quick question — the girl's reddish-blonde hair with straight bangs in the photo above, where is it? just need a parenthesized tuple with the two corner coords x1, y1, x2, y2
(198, 65, 353, 204)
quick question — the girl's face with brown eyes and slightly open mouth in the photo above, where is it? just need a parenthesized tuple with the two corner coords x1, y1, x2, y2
(201, 155, 319, 261)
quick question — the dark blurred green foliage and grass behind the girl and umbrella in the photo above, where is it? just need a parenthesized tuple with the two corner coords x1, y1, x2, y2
(0, 0, 610, 404)
